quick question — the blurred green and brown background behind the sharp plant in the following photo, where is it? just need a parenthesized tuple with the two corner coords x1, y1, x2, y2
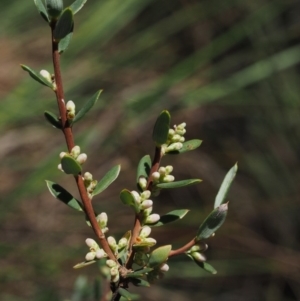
(0, 0, 300, 301)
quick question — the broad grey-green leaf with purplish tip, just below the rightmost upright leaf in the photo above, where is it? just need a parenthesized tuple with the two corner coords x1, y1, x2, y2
(196, 203, 228, 240)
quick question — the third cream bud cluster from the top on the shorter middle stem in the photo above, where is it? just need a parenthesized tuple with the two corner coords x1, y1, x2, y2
(131, 190, 160, 224)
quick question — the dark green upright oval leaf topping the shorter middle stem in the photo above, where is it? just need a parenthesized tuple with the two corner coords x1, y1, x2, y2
(152, 110, 171, 146)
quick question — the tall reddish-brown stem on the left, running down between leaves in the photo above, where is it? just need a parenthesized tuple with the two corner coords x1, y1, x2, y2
(51, 24, 117, 261)
